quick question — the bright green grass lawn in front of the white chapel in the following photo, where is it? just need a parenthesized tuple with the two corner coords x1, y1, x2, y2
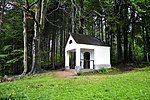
(0, 67, 150, 100)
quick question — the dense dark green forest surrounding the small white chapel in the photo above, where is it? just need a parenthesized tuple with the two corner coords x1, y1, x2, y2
(0, 0, 150, 76)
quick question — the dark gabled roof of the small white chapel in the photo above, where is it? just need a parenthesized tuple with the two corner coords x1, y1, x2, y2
(70, 33, 109, 46)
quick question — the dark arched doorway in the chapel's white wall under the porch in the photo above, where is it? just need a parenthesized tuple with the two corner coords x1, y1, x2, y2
(83, 52, 90, 69)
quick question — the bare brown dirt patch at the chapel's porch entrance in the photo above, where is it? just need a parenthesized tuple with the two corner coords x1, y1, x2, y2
(52, 70, 77, 78)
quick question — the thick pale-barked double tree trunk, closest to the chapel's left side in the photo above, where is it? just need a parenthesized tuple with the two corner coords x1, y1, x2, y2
(30, 0, 47, 74)
